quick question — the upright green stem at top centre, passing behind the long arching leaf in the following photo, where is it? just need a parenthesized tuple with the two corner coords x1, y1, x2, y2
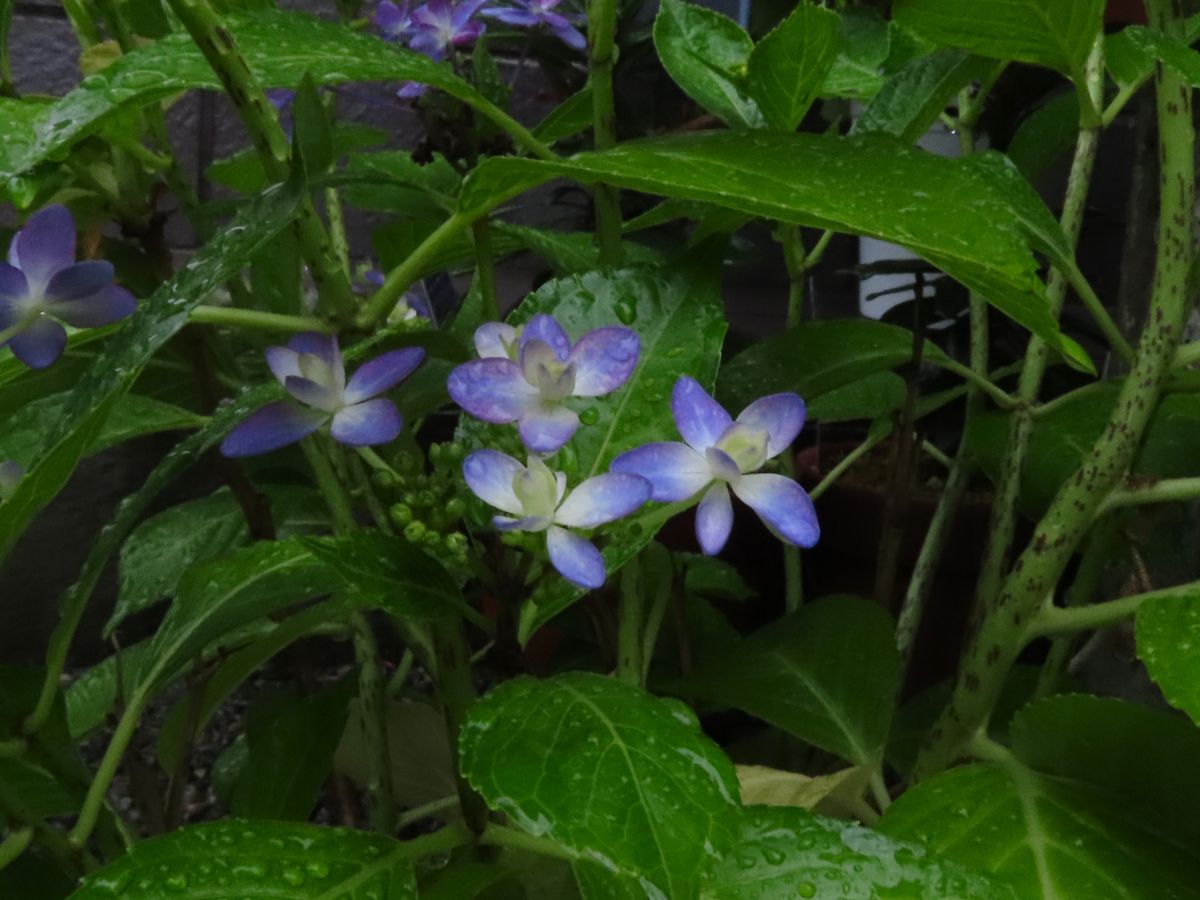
(588, 0, 620, 266)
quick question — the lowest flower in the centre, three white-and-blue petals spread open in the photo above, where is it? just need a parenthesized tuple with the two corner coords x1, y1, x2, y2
(462, 450, 650, 588)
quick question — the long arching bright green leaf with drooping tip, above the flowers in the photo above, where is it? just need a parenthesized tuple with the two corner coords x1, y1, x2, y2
(460, 132, 1088, 367)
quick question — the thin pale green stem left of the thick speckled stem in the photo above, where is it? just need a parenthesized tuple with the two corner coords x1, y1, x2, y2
(976, 40, 1104, 624)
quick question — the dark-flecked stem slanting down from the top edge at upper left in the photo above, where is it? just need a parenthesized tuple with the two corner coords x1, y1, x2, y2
(169, 0, 354, 318)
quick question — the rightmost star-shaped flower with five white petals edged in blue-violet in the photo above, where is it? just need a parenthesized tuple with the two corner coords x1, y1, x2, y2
(611, 376, 821, 556)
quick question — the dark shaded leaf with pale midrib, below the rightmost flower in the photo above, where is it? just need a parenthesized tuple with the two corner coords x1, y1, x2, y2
(683, 596, 900, 764)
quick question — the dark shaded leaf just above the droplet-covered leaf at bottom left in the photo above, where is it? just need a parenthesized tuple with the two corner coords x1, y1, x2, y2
(229, 686, 349, 821)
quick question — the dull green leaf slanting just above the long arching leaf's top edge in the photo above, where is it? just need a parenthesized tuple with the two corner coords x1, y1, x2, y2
(851, 49, 996, 144)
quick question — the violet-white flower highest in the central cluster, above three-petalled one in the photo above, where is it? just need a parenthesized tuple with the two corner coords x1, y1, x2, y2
(448, 313, 641, 454)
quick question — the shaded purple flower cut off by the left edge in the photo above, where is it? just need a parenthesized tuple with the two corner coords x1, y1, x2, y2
(0, 205, 137, 368)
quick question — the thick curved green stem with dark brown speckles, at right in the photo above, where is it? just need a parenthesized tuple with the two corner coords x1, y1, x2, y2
(914, 7, 1195, 780)
